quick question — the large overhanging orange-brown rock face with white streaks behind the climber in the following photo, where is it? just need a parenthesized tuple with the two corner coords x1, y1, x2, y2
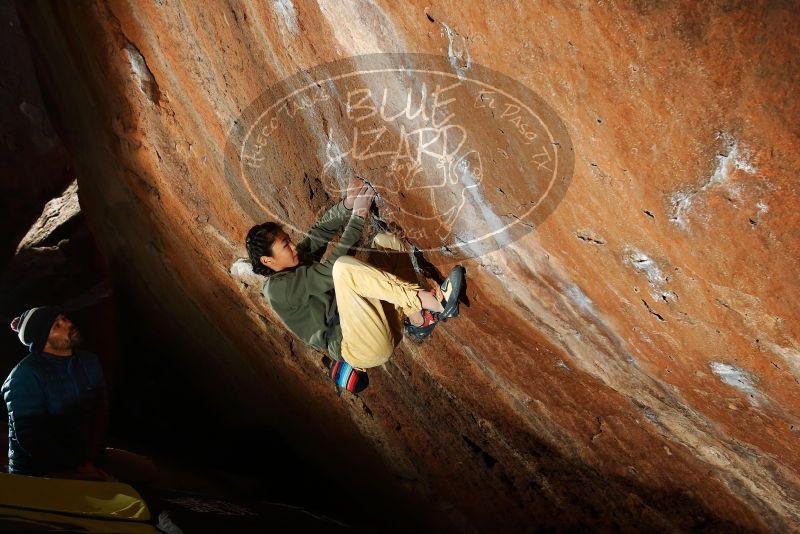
(14, 0, 800, 531)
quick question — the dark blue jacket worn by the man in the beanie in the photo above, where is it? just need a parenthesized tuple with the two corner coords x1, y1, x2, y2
(2, 351, 108, 475)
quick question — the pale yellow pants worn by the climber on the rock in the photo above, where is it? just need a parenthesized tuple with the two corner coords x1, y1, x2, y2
(333, 233, 422, 369)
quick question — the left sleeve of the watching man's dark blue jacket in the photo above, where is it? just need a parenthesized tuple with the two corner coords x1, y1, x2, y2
(3, 367, 74, 472)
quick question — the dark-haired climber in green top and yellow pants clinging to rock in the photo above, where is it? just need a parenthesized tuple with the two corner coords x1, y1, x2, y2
(246, 177, 464, 370)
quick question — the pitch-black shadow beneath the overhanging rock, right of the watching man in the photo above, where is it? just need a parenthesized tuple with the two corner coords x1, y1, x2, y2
(104, 282, 420, 532)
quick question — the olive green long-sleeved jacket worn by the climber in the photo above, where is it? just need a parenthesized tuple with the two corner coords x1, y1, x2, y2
(262, 202, 364, 360)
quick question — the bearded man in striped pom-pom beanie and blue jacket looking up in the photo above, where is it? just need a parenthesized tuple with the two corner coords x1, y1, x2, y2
(2, 306, 156, 483)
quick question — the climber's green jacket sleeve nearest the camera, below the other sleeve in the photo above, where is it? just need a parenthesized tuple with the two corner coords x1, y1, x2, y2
(280, 215, 364, 302)
